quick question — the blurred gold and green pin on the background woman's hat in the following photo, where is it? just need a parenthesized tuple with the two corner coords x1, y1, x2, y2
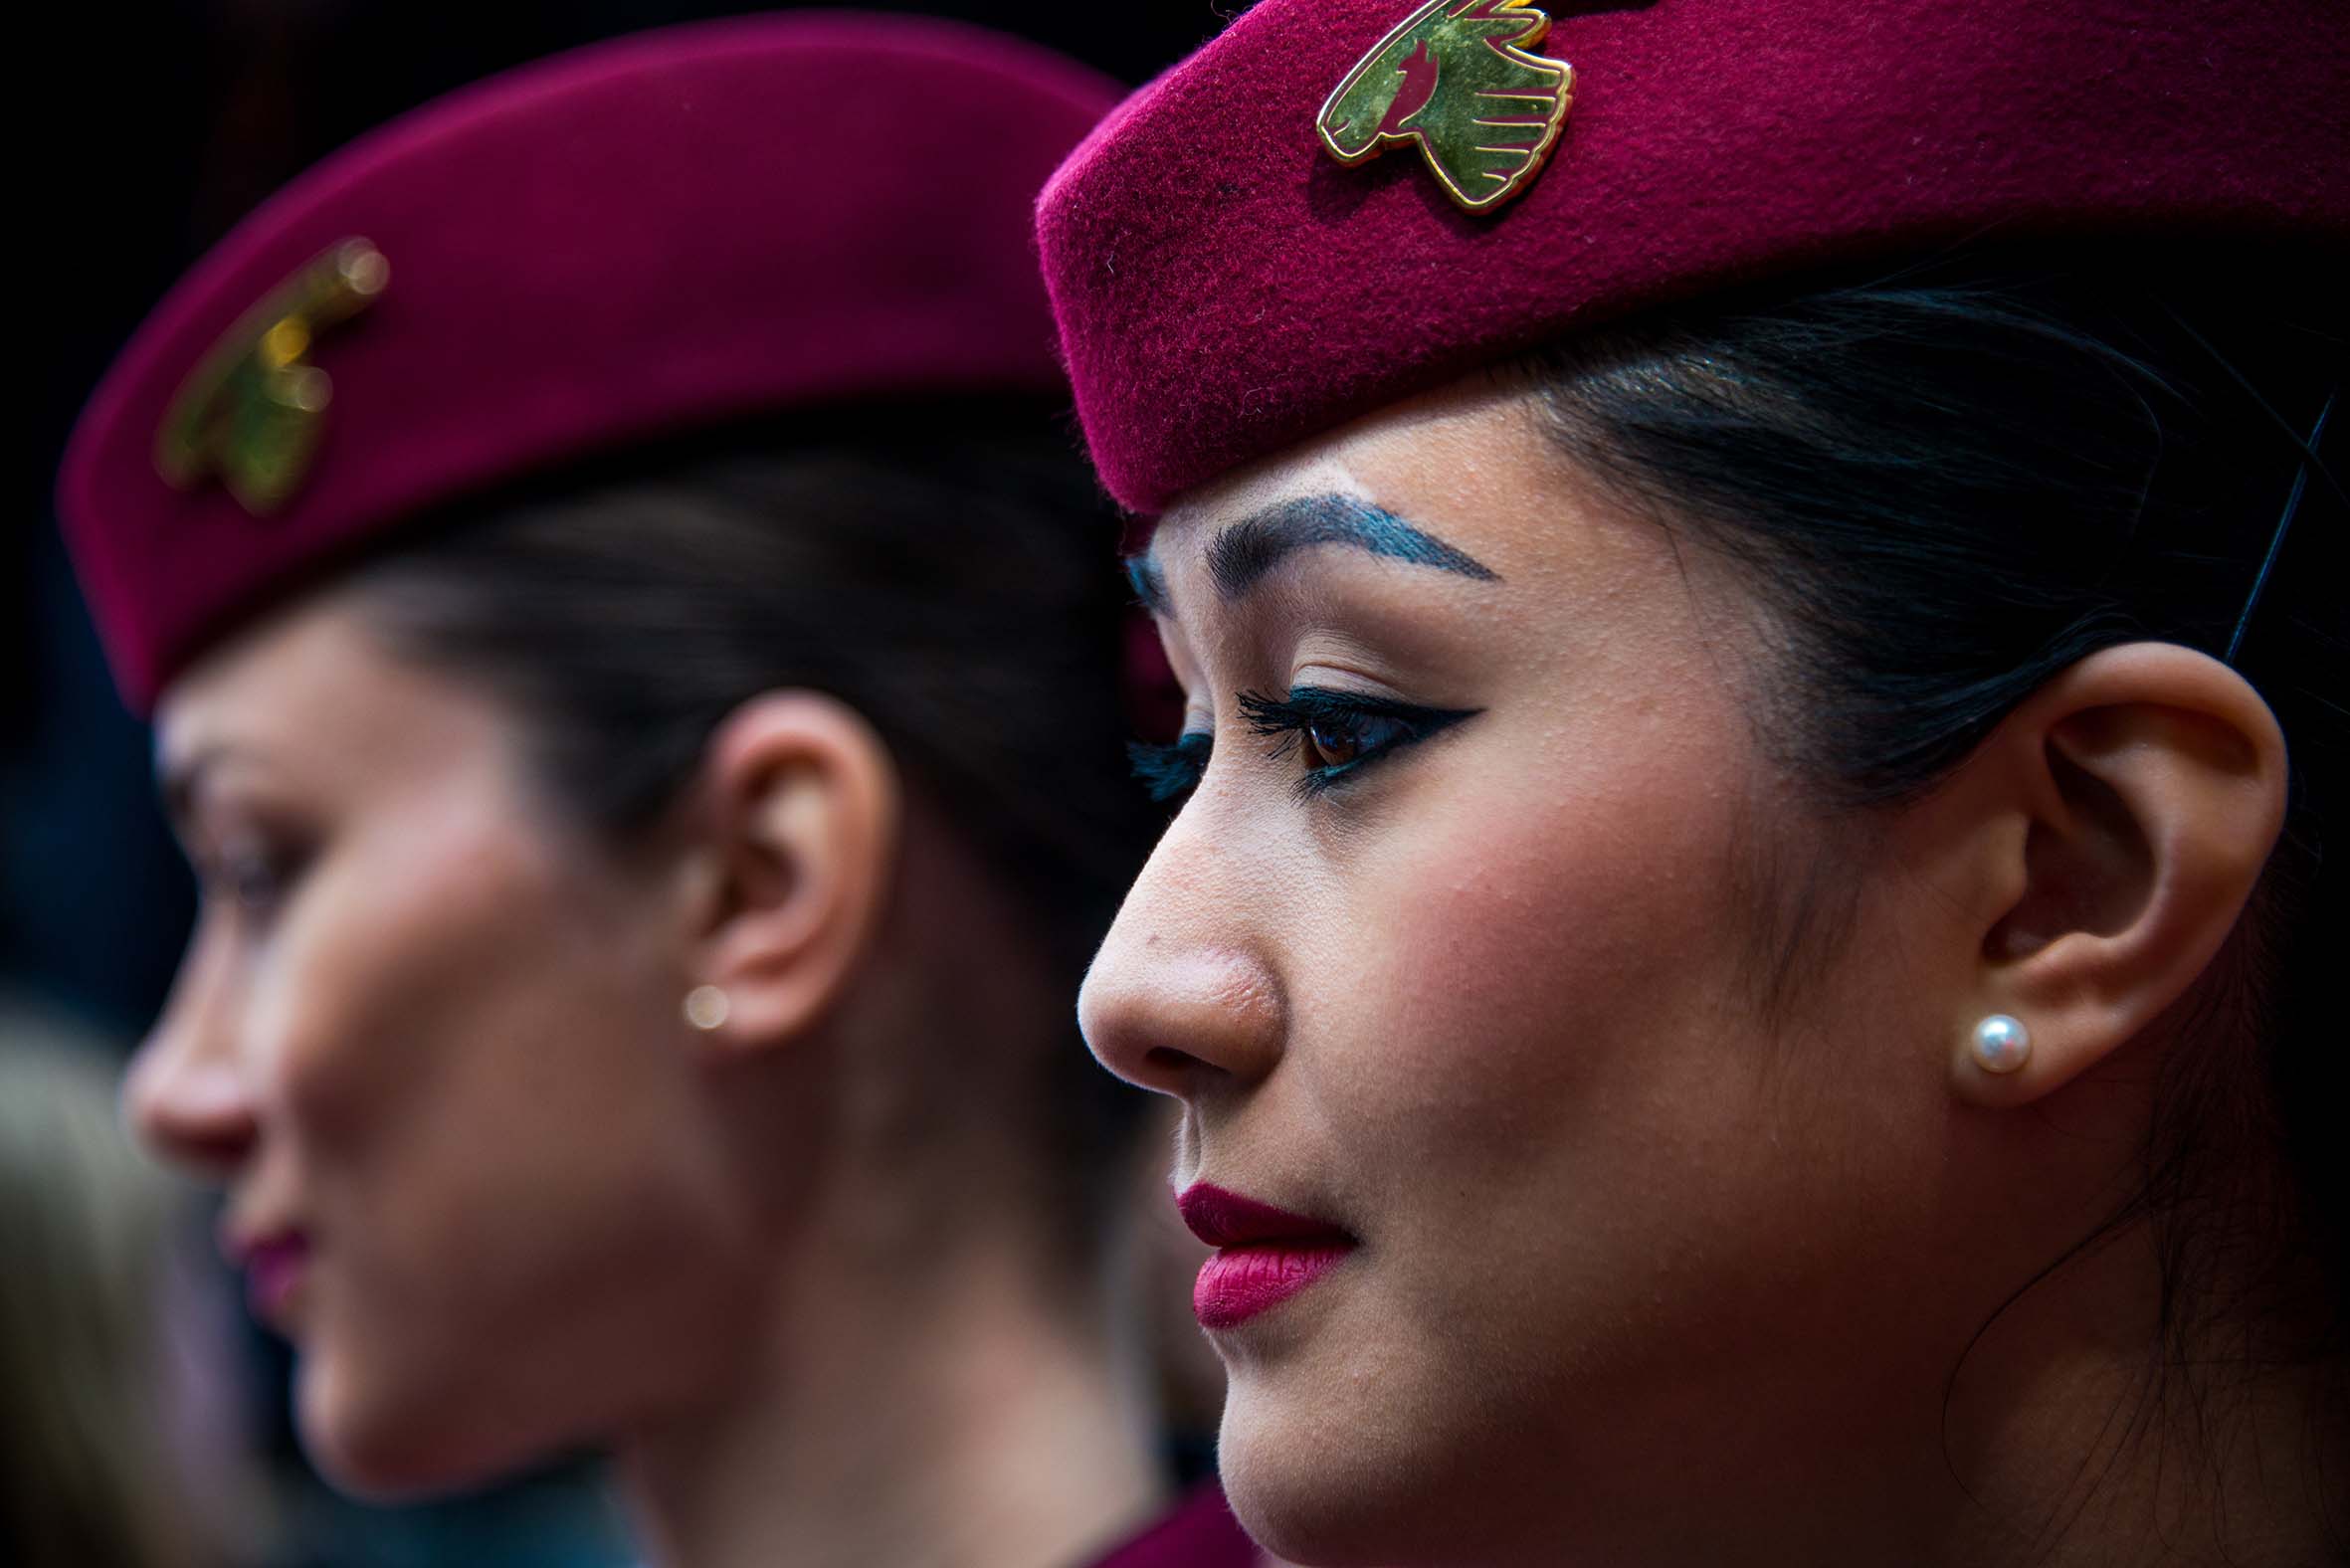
(155, 240, 392, 517)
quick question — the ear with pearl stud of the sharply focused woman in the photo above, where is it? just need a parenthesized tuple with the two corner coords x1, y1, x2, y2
(1950, 642, 2286, 1105)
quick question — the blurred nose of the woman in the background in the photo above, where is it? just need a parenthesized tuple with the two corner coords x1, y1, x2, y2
(122, 933, 259, 1180)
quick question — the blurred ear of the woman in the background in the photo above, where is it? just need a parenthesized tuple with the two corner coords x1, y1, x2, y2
(688, 691, 900, 1054)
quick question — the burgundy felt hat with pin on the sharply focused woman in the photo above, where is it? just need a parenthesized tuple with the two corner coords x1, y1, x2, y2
(1039, 0, 2350, 512)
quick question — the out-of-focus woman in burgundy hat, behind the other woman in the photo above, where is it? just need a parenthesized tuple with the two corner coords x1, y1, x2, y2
(61, 14, 1253, 1568)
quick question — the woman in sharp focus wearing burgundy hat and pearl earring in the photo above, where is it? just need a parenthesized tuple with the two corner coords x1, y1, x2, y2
(1039, 0, 2350, 1568)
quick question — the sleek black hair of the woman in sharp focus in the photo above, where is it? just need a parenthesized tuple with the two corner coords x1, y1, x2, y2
(1532, 245, 2350, 1504)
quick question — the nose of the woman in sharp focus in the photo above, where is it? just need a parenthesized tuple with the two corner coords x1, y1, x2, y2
(1077, 814, 1287, 1100)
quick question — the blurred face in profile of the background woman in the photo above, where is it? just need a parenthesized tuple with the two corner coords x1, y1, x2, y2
(127, 597, 747, 1492)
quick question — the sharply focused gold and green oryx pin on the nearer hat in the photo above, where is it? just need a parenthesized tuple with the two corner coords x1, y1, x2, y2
(1313, 0, 1575, 212)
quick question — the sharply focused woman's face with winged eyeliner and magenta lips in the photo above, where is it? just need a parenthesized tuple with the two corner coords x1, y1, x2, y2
(1081, 390, 2005, 1561)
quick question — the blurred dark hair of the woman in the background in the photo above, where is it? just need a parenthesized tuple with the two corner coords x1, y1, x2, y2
(359, 397, 1156, 1244)
